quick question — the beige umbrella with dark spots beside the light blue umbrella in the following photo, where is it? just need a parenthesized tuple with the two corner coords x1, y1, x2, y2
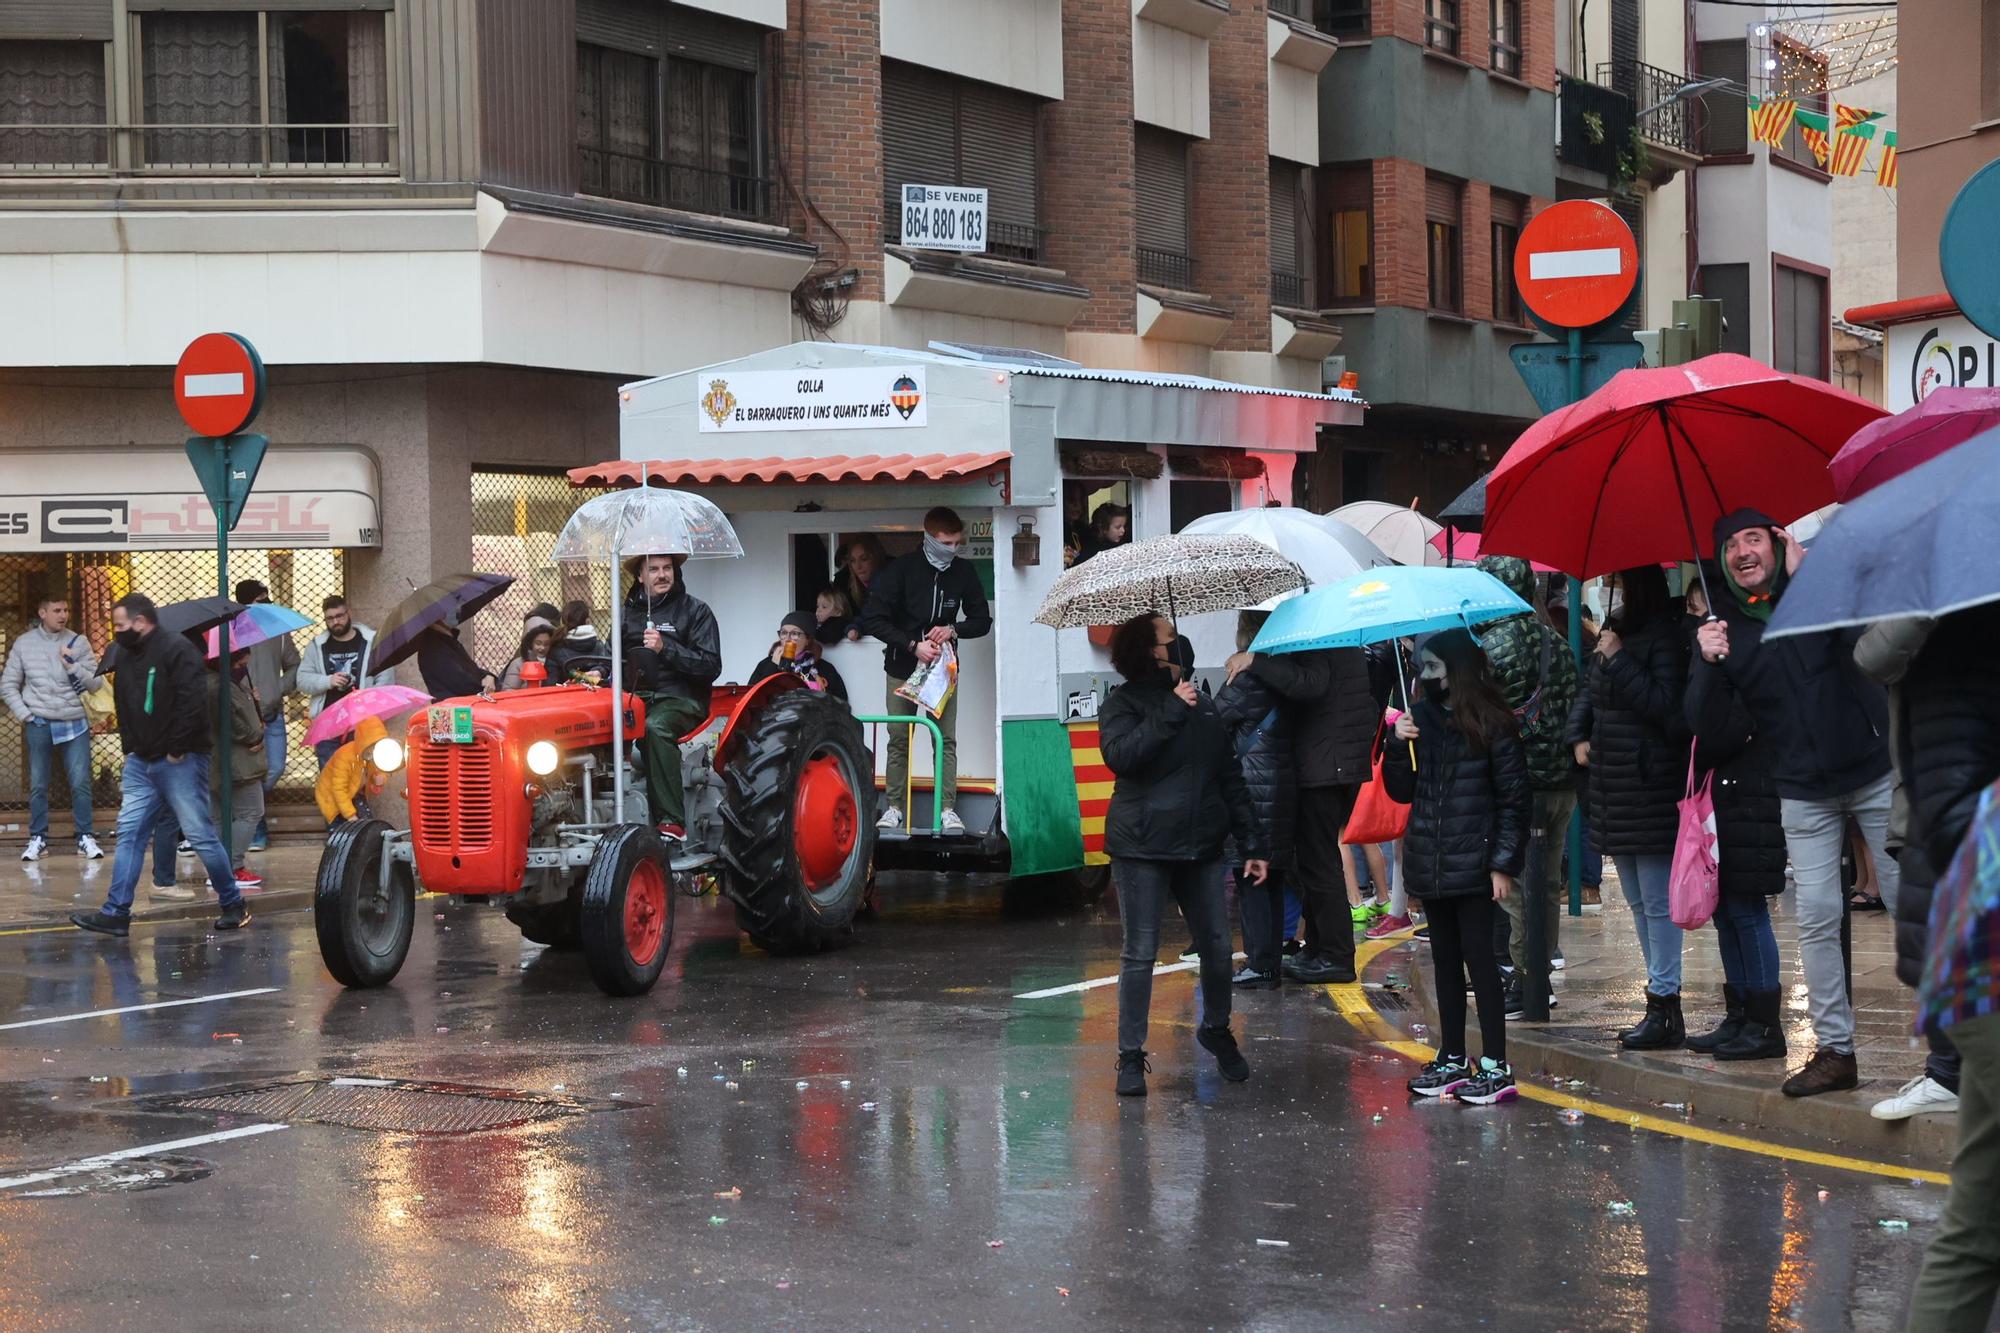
(1034, 532, 1306, 628)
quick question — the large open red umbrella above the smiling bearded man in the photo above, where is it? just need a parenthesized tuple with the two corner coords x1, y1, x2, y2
(1484, 352, 1884, 600)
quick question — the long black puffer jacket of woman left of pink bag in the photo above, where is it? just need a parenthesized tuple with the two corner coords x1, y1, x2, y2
(1564, 614, 1690, 857)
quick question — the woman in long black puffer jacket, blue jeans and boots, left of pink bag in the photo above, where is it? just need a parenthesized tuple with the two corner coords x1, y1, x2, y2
(1566, 564, 1692, 1051)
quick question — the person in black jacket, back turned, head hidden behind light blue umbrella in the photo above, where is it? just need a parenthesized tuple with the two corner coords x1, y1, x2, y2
(1226, 648, 1380, 985)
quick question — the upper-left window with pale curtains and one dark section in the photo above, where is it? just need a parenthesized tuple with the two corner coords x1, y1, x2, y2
(140, 10, 390, 170)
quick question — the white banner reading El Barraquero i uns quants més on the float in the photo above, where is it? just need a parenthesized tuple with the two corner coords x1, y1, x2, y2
(694, 366, 928, 434)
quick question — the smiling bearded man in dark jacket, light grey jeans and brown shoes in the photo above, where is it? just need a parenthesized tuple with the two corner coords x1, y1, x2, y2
(1688, 508, 1898, 1097)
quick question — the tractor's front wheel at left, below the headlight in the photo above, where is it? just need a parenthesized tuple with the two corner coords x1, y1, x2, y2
(312, 819, 416, 991)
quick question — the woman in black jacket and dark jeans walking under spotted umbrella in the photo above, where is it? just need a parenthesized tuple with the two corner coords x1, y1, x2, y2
(1098, 614, 1270, 1097)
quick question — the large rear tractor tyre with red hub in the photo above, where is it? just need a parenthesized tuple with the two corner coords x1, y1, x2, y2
(722, 691, 876, 953)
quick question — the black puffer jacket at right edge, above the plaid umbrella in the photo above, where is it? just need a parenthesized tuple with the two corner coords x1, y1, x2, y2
(1896, 602, 2000, 987)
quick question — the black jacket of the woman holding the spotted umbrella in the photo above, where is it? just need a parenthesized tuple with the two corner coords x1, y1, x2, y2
(1098, 671, 1268, 861)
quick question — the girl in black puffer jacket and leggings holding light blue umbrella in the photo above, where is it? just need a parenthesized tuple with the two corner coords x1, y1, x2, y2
(1382, 630, 1534, 1107)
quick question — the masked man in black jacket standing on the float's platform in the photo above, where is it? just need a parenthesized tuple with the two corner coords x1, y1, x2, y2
(862, 508, 994, 835)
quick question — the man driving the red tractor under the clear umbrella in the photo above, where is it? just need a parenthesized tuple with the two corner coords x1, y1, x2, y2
(618, 554, 722, 845)
